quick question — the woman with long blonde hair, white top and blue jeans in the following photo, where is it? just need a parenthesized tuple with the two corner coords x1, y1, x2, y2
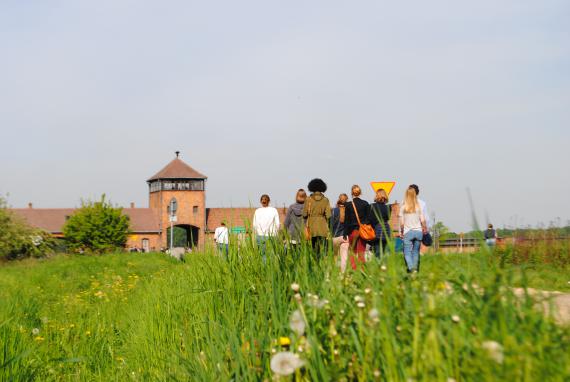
(399, 186, 427, 273)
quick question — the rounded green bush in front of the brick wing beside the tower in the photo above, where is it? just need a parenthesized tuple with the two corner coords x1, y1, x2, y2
(63, 195, 130, 253)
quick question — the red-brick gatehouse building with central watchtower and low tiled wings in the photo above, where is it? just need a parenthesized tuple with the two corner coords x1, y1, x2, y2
(12, 152, 285, 251)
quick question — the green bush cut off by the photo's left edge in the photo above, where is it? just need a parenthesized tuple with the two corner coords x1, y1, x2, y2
(0, 196, 54, 260)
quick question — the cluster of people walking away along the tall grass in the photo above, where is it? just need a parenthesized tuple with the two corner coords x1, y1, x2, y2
(246, 178, 429, 272)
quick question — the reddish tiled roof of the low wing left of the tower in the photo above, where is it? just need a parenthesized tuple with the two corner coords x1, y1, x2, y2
(10, 208, 159, 233)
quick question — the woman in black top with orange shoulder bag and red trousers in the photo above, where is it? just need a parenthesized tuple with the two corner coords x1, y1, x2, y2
(344, 184, 370, 269)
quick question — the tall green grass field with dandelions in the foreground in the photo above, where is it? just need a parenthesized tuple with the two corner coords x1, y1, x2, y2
(0, 243, 570, 381)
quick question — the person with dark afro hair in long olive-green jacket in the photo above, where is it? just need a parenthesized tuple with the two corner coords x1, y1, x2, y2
(303, 178, 331, 258)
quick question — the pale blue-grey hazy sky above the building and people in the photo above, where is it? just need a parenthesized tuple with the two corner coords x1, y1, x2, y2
(0, 0, 570, 232)
